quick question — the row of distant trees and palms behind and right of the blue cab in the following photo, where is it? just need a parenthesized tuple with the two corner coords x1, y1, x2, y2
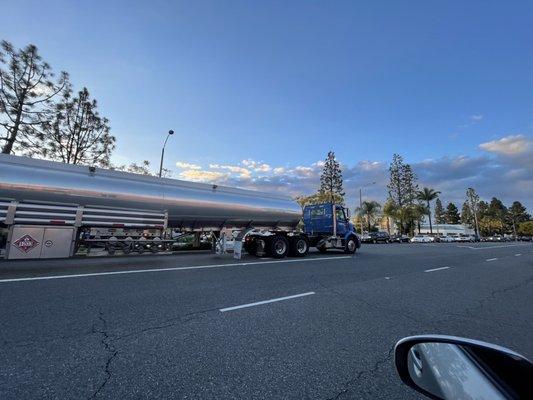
(297, 151, 533, 236)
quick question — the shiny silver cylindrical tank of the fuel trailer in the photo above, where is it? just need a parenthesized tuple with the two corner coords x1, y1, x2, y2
(0, 154, 301, 229)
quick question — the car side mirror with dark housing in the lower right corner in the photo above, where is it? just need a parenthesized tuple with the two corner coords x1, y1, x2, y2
(394, 335, 533, 400)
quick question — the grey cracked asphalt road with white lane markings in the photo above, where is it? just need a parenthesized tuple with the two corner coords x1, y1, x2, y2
(0, 243, 533, 399)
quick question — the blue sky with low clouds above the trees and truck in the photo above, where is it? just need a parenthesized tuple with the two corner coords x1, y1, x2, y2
(0, 1, 533, 207)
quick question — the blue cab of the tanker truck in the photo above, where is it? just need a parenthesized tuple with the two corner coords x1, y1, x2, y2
(303, 203, 361, 254)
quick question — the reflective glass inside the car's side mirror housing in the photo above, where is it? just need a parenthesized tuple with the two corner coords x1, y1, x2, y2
(407, 342, 525, 399)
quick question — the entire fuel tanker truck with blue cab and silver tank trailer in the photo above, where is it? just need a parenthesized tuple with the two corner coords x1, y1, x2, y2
(0, 154, 360, 259)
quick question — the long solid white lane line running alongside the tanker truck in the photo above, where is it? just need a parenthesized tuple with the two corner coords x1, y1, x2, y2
(0, 256, 351, 283)
